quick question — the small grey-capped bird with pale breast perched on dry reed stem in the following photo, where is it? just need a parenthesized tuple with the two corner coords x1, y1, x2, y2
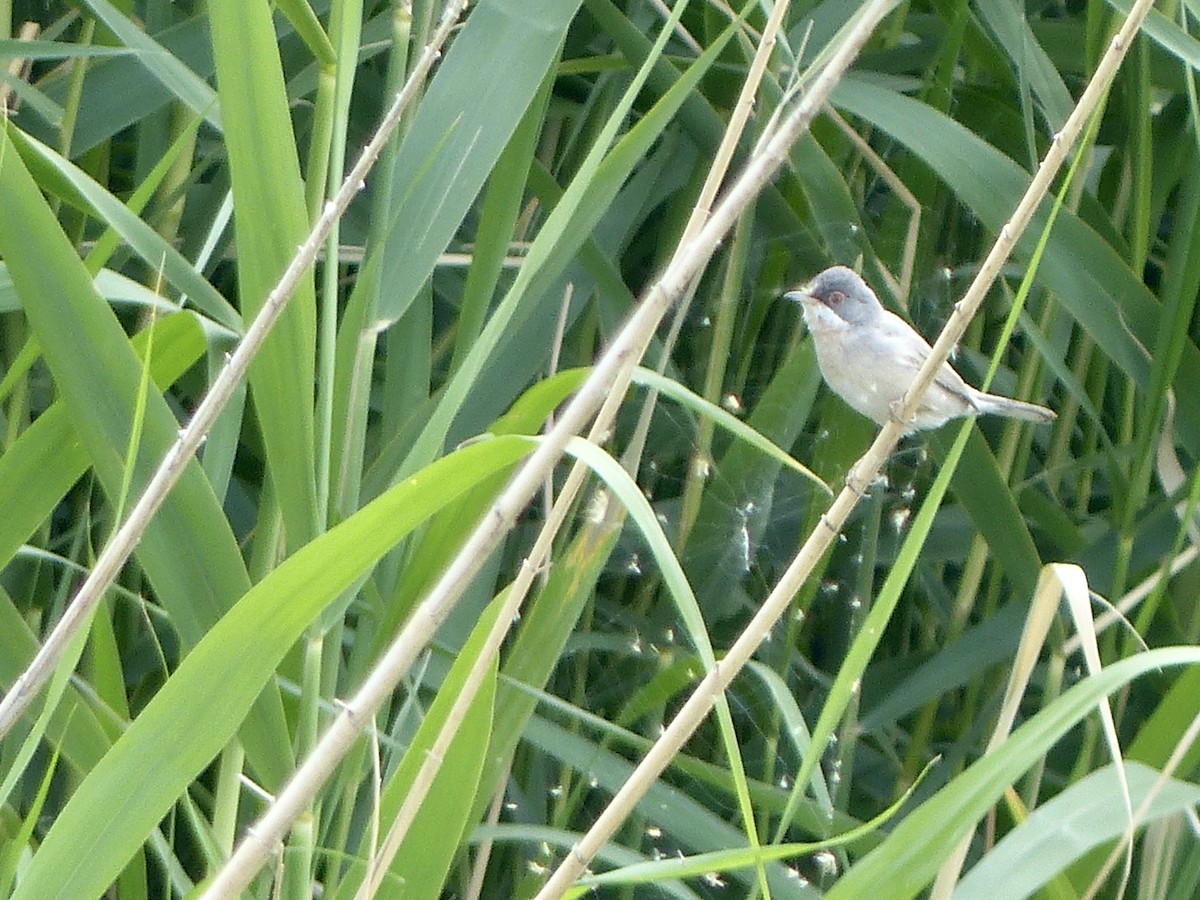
(784, 265, 1057, 433)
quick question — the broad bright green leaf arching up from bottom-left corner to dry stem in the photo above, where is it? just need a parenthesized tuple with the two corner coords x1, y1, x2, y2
(14, 438, 529, 900)
